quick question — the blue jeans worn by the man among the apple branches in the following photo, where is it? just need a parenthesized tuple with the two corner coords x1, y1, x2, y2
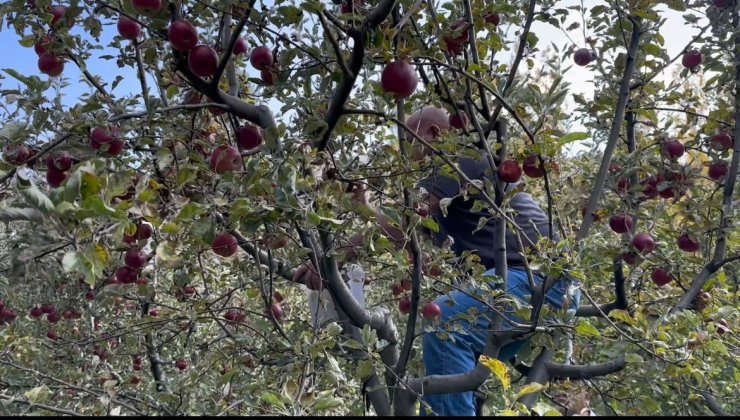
(419, 269, 581, 416)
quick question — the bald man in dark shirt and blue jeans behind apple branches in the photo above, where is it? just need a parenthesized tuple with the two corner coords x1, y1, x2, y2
(294, 107, 580, 416)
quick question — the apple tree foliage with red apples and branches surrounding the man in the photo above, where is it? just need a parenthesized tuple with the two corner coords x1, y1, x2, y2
(0, 0, 740, 415)
